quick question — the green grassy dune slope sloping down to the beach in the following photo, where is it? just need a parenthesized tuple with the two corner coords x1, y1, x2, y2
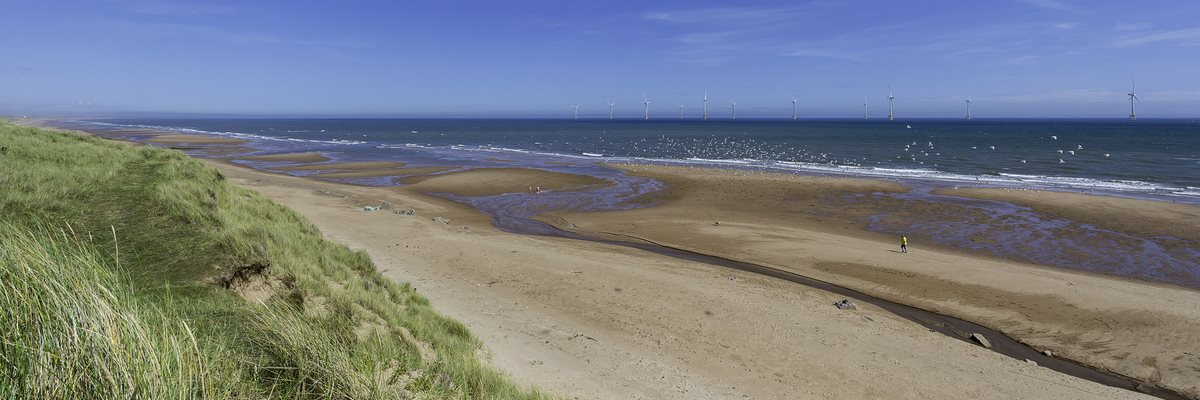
(0, 123, 551, 399)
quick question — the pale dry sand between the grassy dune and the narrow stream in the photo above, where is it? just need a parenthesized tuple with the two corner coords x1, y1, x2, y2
(208, 159, 1161, 399)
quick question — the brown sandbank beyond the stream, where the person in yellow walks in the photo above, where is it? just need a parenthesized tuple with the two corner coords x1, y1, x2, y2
(551, 166, 1200, 396)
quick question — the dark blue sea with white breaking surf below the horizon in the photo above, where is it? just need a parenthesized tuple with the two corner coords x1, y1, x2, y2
(80, 118, 1200, 203)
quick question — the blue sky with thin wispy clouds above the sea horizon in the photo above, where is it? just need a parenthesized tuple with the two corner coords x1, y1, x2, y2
(0, 0, 1200, 118)
